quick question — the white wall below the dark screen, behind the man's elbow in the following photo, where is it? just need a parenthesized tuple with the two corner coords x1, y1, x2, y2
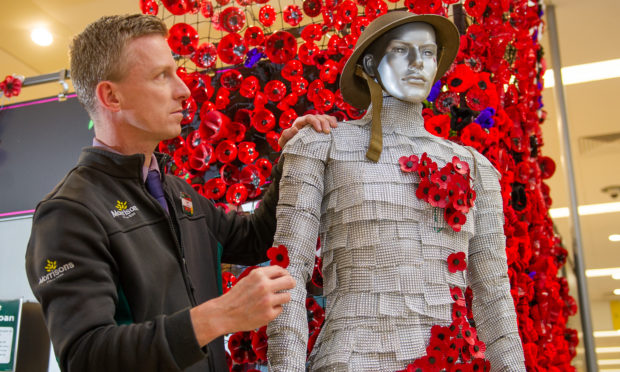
(0, 216, 60, 372)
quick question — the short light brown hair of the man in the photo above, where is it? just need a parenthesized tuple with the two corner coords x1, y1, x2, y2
(69, 14, 168, 117)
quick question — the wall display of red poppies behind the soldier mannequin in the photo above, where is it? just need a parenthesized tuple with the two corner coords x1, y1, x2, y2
(140, 0, 578, 371)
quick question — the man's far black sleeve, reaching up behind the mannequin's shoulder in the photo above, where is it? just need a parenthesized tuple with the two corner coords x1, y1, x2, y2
(209, 159, 282, 266)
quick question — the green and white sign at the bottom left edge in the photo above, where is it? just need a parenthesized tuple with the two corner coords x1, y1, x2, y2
(0, 299, 22, 371)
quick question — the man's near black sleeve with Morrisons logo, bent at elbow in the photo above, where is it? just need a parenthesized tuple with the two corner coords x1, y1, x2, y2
(26, 199, 205, 372)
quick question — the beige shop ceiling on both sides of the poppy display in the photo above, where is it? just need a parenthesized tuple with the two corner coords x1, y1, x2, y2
(0, 0, 620, 370)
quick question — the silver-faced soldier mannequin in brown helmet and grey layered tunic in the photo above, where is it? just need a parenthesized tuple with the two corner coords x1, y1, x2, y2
(267, 12, 525, 372)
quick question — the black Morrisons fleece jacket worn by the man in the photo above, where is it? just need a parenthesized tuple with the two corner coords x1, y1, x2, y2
(26, 147, 279, 372)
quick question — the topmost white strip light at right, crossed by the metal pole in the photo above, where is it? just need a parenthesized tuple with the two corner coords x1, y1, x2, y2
(543, 59, 620, 88)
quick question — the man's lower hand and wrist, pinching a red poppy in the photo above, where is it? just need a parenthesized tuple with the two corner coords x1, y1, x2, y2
(190, 266, 295, 347)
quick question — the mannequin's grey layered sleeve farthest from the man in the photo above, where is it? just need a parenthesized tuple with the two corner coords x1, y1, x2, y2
(467, 153, 525, 372)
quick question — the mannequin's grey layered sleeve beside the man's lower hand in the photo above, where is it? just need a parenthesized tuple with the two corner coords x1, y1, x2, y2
(267, 129, 331, 372)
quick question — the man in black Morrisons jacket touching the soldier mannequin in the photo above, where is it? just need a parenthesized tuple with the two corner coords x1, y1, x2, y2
(26, 15, 335, 372)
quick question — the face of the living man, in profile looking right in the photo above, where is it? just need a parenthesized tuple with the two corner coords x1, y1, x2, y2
(115, 35, 190, 143)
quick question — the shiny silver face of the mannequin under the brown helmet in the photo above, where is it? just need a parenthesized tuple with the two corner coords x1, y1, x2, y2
(363, 22, 437, 103)
